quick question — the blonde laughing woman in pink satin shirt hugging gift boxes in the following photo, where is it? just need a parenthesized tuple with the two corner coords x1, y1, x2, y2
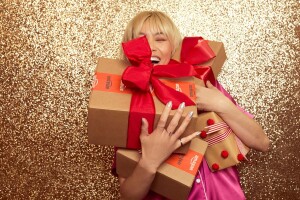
(114, 11, 269, 200)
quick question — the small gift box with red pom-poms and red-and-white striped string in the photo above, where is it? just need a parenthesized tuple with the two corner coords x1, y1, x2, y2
(198, 112, 249, 171)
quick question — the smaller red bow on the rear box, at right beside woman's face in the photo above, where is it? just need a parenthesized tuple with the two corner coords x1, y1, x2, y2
(180, 37, 216, 85)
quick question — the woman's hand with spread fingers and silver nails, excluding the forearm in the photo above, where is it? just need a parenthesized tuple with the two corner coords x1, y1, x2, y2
(140, 102, 199, 172)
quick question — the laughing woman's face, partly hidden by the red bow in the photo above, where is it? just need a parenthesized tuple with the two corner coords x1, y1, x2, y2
(139, 21, 173, 65)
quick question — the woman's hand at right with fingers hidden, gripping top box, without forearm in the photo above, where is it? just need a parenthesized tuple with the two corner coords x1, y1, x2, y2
(196, 81, 234, 114)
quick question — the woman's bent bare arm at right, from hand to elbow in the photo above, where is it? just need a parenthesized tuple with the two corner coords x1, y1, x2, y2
(197, 81, 270, 152)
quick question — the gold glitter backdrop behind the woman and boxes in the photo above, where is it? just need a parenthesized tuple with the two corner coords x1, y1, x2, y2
(0, 0, 300, 199)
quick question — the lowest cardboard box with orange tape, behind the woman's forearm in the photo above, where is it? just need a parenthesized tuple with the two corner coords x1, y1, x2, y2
(116, 138, 207, 200)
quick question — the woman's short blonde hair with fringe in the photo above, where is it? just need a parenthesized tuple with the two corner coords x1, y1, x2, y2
(120, 11, 181, 59)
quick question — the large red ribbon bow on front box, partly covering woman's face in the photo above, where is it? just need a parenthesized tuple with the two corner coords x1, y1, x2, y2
(122, 36, 197, 148)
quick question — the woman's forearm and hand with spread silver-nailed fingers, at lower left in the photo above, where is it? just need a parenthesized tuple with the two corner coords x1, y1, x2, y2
(119, 103, 199, 200)
